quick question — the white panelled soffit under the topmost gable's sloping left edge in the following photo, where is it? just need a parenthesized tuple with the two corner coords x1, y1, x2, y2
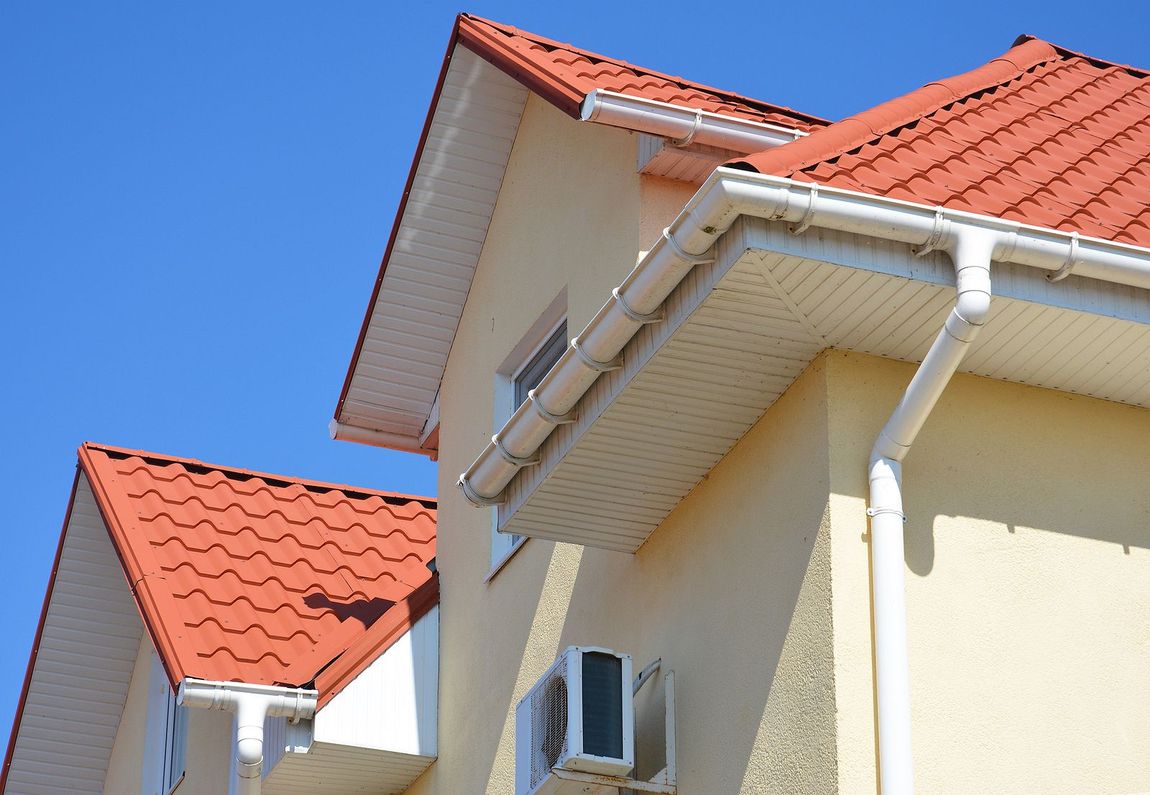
(337, 46, 528, 448)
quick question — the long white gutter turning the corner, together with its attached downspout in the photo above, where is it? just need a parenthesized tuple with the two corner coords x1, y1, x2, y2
(450, 168, 1150, 795)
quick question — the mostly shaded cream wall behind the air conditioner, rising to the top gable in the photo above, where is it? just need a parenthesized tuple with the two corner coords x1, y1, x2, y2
(418, 97, 836, 794)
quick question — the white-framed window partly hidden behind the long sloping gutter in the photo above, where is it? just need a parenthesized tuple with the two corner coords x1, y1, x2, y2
(488, 290, 567, 579)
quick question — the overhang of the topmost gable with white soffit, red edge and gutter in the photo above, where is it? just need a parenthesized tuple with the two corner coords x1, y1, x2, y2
(330, 23, 804, 458)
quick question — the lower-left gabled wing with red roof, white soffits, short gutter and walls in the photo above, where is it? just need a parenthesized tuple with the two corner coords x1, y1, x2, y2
(0, 444, 438, 795)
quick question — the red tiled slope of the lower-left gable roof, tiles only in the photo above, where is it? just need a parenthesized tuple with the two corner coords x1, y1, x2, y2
(79, 444, 438, 701)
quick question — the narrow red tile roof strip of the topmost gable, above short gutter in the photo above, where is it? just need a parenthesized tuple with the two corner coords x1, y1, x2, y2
(457, 14, 829, 130)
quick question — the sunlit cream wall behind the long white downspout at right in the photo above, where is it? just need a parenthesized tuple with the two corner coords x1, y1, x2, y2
(826, 352, 1150, 793)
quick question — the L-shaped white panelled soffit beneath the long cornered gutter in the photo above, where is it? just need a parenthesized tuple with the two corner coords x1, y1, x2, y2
(499, 219, 1150, 551)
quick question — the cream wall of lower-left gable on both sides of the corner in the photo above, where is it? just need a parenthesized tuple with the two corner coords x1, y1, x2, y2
(104, 634, 232, 795)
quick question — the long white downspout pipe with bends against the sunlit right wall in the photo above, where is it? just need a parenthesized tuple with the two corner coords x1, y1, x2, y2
(867, 228, 998, 795)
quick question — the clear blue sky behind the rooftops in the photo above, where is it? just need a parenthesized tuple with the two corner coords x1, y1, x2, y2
(0, 0, 1150, 749)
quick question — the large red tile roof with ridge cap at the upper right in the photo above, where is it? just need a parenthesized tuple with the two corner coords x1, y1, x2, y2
(734, 37, 1150, 246)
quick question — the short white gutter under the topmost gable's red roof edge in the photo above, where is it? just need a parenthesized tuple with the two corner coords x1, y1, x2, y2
(580, 89, 806, 154)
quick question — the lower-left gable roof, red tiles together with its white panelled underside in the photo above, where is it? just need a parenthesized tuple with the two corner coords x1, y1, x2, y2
(0, 443, 439, 792)
